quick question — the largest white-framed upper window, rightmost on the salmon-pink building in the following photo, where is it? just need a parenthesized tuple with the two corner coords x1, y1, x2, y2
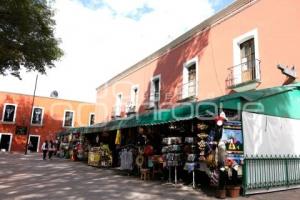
(231, 29, 260, 85)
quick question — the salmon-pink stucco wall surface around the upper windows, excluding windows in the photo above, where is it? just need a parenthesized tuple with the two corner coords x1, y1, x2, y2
(96, 0, 300, 122)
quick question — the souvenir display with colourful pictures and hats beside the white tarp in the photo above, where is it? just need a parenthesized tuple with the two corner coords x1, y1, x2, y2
(190, 112, 243, 198)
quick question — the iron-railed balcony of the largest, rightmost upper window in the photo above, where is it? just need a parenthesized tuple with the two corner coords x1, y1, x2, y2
(226, 59, 261, 92)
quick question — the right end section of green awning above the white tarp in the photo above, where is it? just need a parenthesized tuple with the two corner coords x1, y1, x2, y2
(219, 83, 300, 119)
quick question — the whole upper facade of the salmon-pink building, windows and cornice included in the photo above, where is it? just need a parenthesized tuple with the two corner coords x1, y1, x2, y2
(95, 0, 300, 122)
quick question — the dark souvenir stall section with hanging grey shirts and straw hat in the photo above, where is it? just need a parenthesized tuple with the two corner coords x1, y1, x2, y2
(116, 126, 163, 180)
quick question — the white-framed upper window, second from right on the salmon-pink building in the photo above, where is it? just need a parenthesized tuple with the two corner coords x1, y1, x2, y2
(179, 57, 198, 99)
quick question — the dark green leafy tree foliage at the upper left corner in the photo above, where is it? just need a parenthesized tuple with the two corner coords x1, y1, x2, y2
(0, 0, 63, 79)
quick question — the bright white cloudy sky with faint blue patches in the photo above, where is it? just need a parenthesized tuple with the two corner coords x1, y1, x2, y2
(0, 0, 234, 102)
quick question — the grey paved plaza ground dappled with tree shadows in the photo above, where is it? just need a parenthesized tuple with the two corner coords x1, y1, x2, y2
(0, 153, 300, 200)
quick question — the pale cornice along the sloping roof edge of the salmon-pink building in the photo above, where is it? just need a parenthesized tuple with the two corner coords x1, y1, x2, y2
(96, 0, 259, 90)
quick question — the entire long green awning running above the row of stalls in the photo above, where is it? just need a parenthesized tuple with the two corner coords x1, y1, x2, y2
(67, 83, 300, 134)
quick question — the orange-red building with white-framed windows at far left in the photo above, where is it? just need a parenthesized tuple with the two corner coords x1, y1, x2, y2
(0, 92, 95, 152)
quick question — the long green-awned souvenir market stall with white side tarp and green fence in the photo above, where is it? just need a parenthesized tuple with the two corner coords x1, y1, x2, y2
(63, 84, 300, 197)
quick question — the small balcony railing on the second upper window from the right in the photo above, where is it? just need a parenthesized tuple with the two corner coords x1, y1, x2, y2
(177, 80, 197, 102)
